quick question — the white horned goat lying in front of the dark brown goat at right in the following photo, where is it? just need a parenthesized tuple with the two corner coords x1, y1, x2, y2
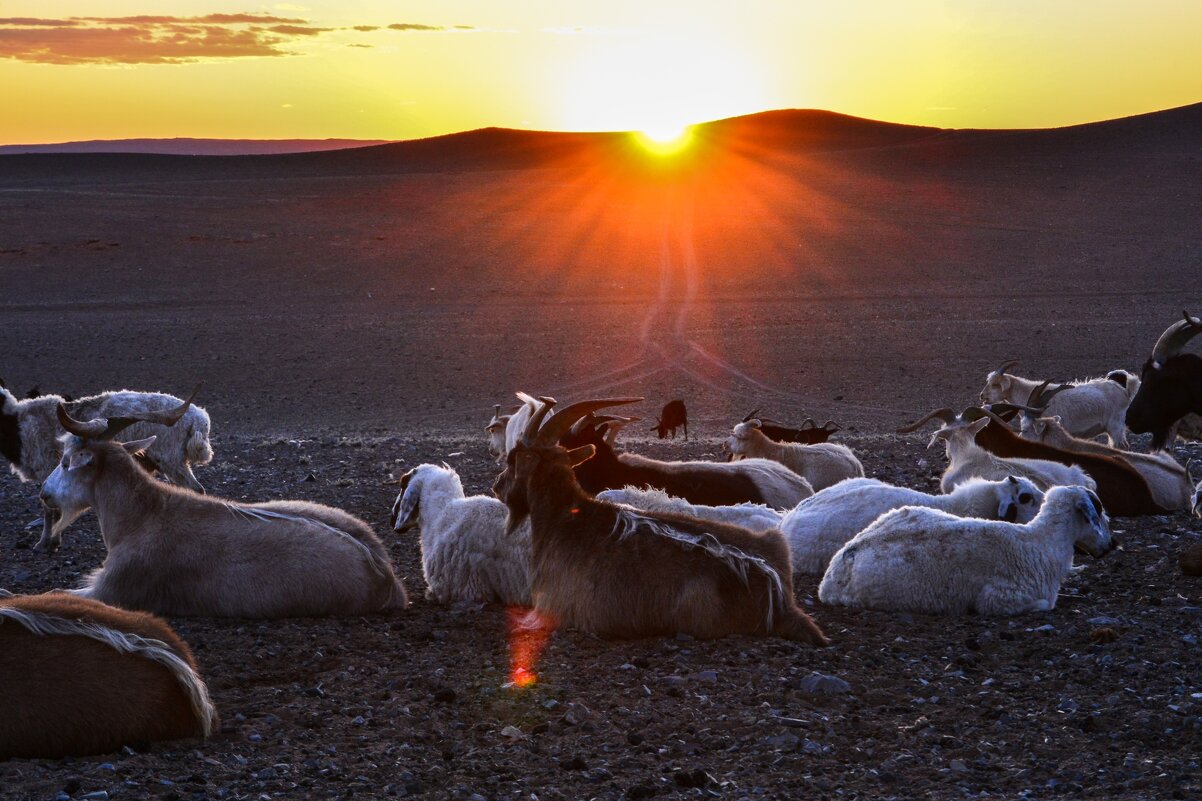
(927, 417, 1097, 492)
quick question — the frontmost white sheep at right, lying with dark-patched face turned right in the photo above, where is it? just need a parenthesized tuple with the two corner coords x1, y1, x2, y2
(819, 487, 1114, 615)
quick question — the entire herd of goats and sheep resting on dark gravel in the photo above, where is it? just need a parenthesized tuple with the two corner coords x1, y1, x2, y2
(0, 314, 1202, 759)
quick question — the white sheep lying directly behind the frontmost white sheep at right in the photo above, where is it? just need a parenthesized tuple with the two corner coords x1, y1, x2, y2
(780, 475, 1043, 576)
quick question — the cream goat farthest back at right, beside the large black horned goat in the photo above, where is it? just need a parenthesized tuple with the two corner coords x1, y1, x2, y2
(981, 360, 1139, 449)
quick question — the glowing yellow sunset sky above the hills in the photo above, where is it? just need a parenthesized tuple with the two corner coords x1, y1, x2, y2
(0, 0, 1202, 144)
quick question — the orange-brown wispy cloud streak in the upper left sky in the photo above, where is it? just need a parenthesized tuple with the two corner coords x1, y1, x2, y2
(0, 13, 334, 64)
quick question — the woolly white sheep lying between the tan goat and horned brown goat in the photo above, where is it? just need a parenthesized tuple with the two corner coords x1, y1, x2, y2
(389, 464, 530, 606)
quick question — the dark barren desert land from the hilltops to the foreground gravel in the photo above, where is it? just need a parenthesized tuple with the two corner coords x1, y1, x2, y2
(0, 106, 1202, 801)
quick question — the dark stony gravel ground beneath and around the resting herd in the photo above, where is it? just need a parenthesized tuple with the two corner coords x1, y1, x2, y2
(0, 433, 1202, 801)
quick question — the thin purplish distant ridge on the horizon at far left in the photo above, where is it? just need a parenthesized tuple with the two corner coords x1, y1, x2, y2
(0, 137, 392, 156)
